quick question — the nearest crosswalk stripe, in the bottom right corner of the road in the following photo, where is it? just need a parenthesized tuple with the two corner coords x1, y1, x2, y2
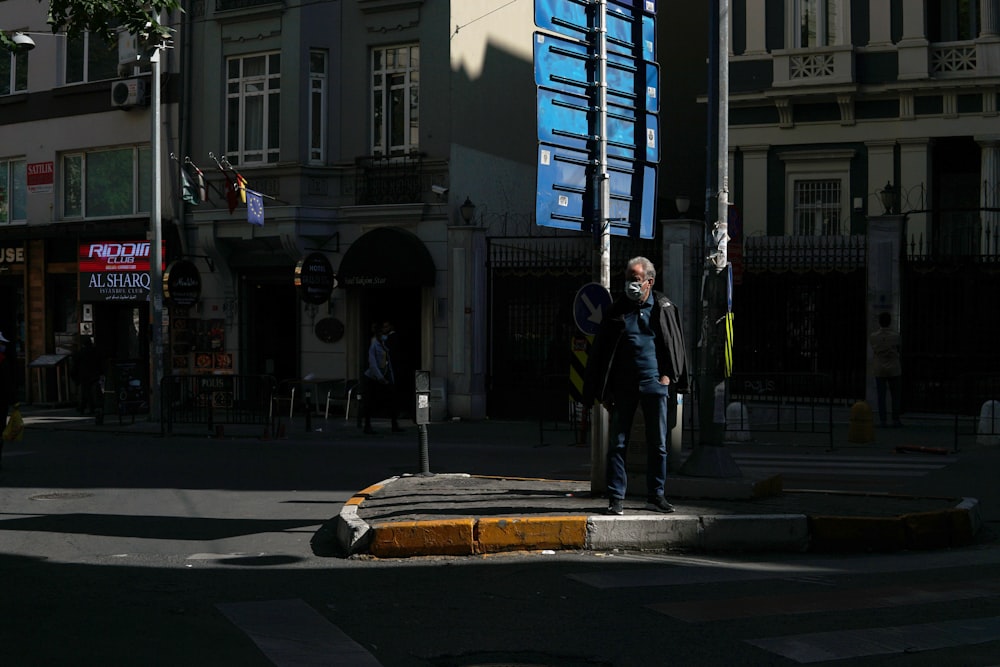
(746, 616, 1000, 664)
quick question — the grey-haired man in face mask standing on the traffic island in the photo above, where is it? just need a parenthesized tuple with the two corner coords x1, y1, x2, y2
(583, 257, 688, 515)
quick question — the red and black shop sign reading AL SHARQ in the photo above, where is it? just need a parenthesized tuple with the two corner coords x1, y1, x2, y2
(79, 241, 161, 302)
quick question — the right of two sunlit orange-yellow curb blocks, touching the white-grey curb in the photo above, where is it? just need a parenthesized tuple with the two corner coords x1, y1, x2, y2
(475, 516, 587, 553)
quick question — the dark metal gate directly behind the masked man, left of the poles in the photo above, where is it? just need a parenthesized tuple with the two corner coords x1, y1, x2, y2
(486, 236, 660, 421)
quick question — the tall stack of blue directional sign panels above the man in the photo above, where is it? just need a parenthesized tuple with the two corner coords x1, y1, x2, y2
(534, 0, 660, 238)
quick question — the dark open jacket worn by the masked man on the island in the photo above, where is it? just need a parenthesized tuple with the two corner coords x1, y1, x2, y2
(583, 291, 688, 406)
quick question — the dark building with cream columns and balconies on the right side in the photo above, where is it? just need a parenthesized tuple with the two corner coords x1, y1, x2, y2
(729, 0, 1000, 410)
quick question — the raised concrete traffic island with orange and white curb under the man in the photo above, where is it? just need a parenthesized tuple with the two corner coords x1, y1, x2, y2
(322, 474, 982, 558)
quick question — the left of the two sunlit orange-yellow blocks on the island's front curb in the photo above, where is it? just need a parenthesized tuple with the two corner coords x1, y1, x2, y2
(368, 518, 476, 558)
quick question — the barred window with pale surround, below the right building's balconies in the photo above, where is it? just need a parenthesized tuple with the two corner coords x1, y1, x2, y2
(778, 149, 854, 236)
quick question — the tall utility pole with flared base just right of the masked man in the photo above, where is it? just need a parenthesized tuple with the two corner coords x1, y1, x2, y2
(680, 0, 742, 477)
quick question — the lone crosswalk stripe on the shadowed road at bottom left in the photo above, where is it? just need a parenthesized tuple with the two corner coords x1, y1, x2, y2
(216, 599, 381, 667)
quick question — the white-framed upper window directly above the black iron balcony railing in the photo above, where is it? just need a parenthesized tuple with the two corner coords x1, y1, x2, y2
(371, 44, 420, 156)
